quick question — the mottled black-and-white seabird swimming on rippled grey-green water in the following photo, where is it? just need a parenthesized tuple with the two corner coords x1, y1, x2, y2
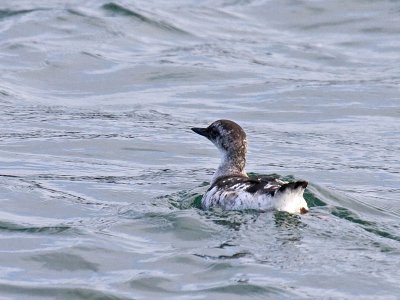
(192, 120, 308, 214)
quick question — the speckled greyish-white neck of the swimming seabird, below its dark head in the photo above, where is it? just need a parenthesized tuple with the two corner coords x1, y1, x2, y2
(212, 151, 247, 183)
